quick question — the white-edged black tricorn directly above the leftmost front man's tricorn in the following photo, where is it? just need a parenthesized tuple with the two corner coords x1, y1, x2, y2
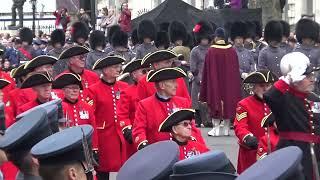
(24, 55, 58, 70)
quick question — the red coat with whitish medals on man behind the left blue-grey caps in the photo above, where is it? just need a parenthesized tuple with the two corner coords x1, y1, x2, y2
(62, 99, 98, 150)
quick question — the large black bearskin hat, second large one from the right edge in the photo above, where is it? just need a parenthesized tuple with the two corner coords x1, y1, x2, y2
(264, 20, 283, 43)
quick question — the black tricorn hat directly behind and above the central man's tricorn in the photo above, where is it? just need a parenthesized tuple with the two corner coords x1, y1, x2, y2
(141, 50, 178, 65)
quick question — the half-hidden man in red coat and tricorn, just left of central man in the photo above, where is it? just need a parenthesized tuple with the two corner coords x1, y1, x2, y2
(117, 59, 146, 158)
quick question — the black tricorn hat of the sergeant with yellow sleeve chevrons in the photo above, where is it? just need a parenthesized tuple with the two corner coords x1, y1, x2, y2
(243, 70, 278, 84)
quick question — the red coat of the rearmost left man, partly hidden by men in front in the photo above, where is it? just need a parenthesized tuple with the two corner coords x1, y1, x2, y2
(63, 69, 99, 102)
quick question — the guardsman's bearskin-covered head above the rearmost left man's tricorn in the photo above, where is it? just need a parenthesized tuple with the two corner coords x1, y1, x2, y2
(71, 21, 90, 47)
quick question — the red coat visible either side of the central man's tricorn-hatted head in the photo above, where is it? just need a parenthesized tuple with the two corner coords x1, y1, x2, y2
(138, 75, 191, 101)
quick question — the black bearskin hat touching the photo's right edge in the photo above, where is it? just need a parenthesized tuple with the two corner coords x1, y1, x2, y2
(296, 19, 319, 44)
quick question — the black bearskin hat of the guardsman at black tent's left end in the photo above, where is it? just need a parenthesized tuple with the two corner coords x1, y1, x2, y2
(138, 20, 157, 42)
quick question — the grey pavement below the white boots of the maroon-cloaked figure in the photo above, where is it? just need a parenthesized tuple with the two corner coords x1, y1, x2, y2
(200, 128, 239, 168)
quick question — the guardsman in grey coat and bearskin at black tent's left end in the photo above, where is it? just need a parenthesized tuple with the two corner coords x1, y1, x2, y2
(136, 20, 157, 59)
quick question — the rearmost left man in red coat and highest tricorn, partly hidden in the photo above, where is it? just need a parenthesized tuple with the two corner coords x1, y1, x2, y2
(59, 46, 99, 102)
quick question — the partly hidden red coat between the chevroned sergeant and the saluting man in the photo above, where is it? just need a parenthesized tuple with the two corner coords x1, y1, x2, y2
(257, 127, 279, 160)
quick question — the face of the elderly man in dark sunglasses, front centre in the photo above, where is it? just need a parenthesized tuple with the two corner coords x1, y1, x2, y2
(172, 120, 192, 139)
